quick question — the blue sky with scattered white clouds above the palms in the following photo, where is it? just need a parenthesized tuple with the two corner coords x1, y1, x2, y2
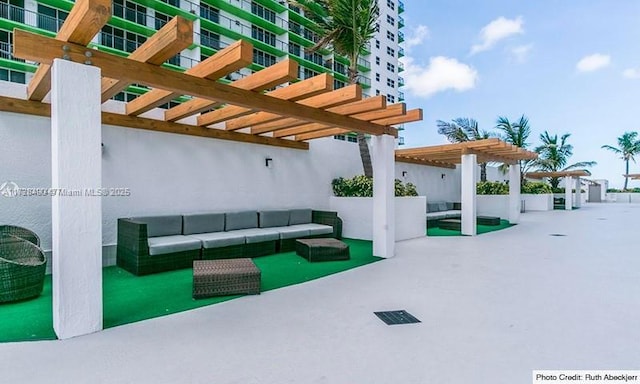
(401, 0, 640, 187)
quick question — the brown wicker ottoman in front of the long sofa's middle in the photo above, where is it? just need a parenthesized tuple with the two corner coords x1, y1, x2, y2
(193, 259, 260, 299)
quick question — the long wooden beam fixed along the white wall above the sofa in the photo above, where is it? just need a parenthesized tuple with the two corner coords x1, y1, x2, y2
(0, 96, 309, 150)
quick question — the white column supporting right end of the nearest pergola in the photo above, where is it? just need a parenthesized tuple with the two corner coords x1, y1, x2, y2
(371, 135, 396, 257)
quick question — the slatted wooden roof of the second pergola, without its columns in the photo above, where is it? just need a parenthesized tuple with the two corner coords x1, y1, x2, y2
(396, 138, 538, 168)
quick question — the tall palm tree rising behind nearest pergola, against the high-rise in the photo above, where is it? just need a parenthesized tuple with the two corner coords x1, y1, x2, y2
(289, 0, 380, 177)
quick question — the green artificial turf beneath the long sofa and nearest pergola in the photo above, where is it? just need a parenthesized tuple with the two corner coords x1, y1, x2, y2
(0, 239, 381, 342)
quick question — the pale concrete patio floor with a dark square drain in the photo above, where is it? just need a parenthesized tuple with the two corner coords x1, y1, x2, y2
(0, 204, 640, 384)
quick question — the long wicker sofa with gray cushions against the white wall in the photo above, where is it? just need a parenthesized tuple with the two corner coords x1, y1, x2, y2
(117, 209, 342, 275)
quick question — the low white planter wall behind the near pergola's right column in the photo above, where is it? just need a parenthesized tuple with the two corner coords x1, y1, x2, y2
(329, 196, 427, 241)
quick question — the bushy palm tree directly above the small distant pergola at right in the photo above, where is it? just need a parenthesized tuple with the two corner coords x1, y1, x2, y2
(534, 131, 597, 189)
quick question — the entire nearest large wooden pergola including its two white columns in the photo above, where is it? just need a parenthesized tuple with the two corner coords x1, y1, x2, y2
(0, 0, 422, 339)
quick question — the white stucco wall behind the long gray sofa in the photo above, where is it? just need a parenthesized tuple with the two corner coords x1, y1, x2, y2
(0, 112, 362, 250)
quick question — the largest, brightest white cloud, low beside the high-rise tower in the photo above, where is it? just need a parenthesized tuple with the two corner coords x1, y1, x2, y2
(403, 56, 478, 97)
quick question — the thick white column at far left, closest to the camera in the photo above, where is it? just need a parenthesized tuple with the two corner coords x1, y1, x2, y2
(51, 59, 102, 339)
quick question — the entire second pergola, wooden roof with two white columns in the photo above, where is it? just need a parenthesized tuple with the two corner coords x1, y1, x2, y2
(395, 138, 538, 236)
